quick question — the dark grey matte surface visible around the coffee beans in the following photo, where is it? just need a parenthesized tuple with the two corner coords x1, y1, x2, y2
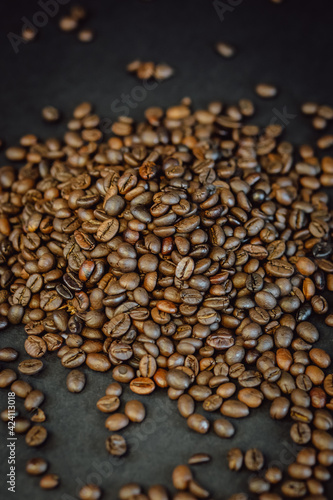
(0, 0, 333, 500)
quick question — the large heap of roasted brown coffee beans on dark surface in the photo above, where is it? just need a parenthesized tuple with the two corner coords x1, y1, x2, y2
(0, 98, 333, 500)
